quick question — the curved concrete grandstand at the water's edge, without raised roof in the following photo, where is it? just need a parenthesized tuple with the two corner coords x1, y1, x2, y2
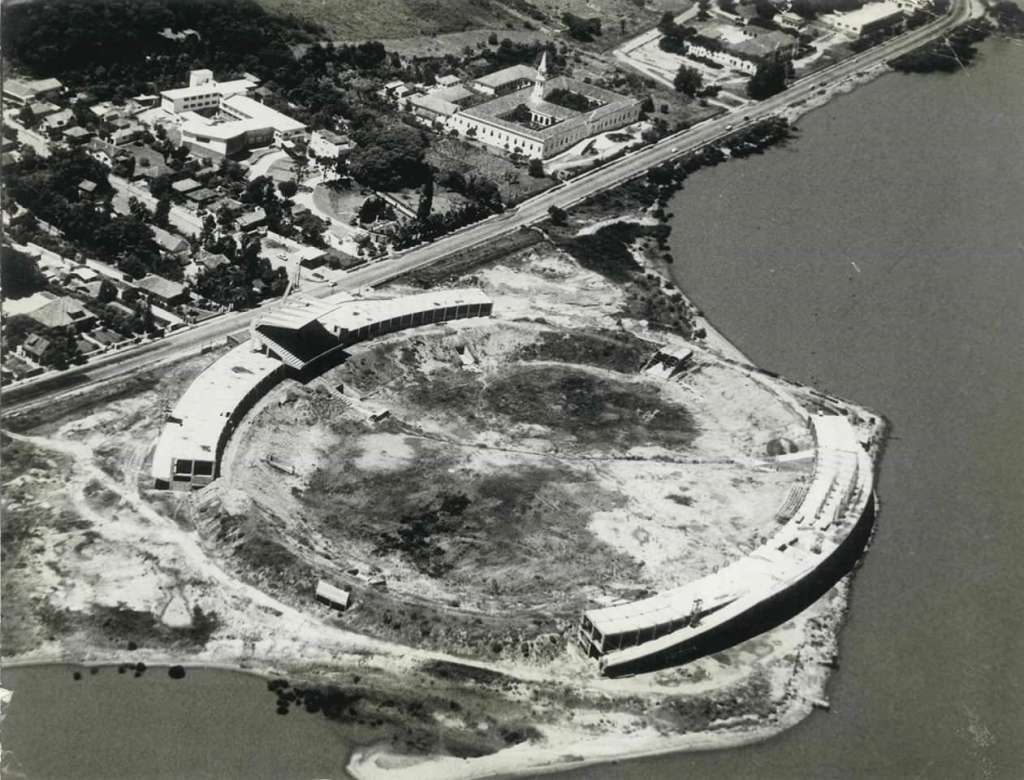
(578, 415, 873, 676)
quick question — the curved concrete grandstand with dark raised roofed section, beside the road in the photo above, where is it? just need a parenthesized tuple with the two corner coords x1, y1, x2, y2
(152, 288, 494, 488)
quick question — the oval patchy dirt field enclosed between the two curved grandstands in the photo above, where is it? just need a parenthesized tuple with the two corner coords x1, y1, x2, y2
(207, 290, 811, 651)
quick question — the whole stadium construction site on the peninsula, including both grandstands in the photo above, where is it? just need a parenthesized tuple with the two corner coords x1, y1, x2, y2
(3, 222, 882, 777)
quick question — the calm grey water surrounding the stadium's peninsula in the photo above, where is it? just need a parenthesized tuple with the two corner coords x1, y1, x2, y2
(3, 36, 1024, 780)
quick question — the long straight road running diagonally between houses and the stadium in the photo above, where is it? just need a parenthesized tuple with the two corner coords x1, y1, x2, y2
(3, 0, 970, 417)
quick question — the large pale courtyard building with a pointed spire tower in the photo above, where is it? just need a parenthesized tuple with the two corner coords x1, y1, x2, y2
(436, 54, 640, 158)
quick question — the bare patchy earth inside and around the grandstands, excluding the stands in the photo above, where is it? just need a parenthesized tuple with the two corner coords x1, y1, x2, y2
(0, 215, 884, 777)
